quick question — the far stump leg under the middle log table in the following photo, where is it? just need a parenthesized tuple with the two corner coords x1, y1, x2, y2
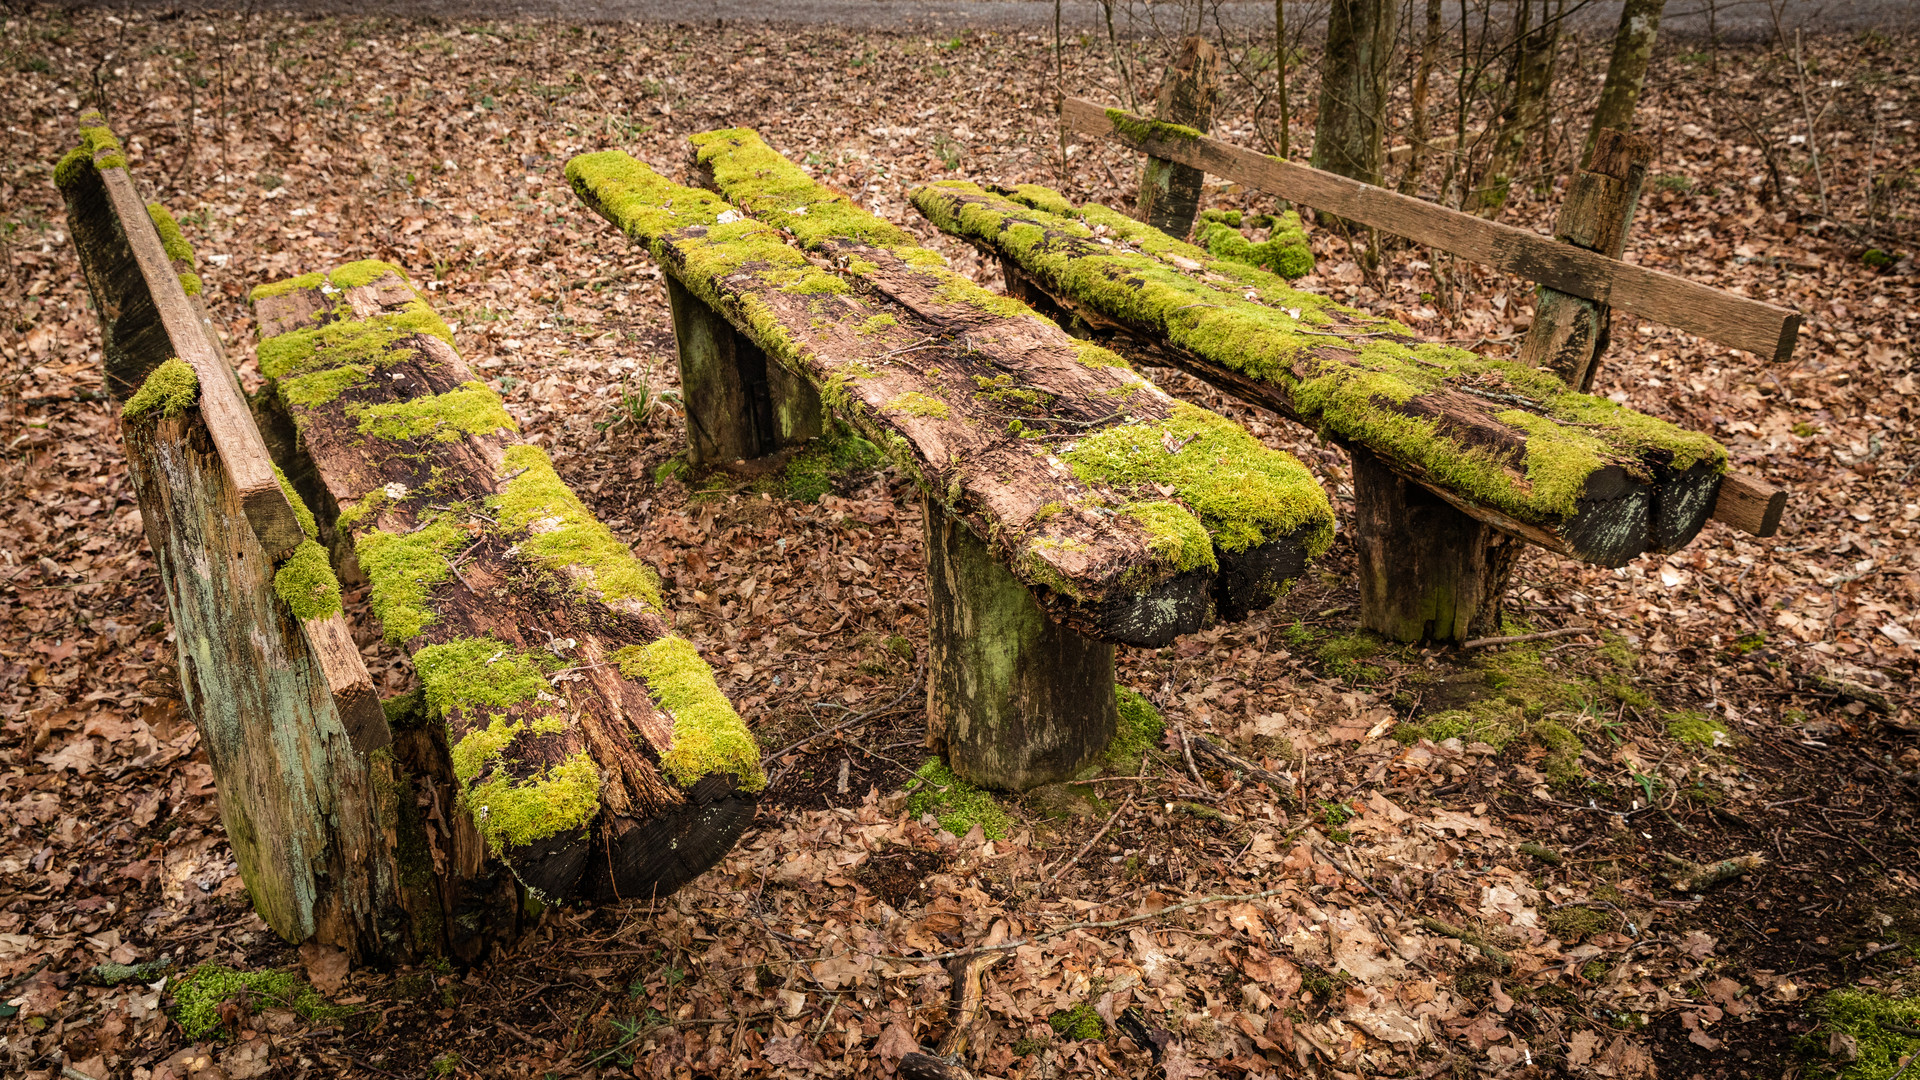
(666, 275, 826, 465)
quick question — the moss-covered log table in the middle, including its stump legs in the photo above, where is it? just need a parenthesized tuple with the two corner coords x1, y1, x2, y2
(566, 131, 1332, 790)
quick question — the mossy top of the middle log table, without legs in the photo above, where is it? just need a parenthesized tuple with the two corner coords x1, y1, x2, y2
(568, 142, 1331, 644)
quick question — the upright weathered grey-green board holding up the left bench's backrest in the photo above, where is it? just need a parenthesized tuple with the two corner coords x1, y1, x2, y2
(125, 411, 394, 955)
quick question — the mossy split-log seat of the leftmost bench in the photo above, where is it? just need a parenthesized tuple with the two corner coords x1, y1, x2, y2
(252, 261, 766, 899)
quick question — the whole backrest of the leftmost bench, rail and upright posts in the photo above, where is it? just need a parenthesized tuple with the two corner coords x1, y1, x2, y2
(56, 115, 520, 963)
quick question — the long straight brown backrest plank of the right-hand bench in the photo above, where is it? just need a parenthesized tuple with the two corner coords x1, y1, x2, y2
(1062, 98, 1801, 363)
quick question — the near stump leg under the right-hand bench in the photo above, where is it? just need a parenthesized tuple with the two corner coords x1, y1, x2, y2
(1348, 446, 1521, 642)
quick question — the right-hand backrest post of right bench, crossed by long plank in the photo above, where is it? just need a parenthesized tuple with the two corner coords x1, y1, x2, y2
(1519, 129, 1653, 390)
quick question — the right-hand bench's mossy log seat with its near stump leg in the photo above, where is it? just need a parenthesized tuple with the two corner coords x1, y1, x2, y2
(912, 181, 1758, 640)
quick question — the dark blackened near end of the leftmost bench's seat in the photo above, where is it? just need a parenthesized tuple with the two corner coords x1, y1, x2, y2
(580, 773, 758, 903)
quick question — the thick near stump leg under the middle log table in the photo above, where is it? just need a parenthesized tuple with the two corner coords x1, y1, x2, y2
(922, 500, 1119, 792)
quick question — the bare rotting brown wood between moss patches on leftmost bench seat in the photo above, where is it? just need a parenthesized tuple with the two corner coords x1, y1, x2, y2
(255, 263, 764, 899)
